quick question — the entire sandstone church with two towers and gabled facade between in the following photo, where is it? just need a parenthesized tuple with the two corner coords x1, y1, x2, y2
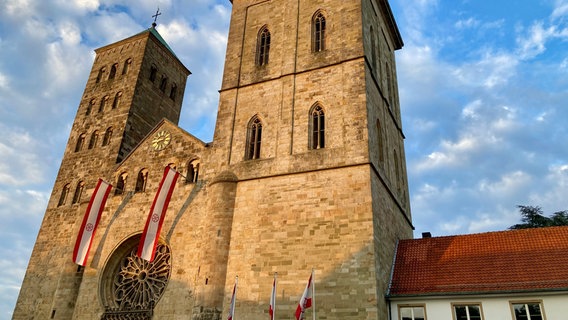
(14, 0, 413, 320)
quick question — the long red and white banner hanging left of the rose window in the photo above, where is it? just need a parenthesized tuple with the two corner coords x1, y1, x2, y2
(73, 179, 112, 266)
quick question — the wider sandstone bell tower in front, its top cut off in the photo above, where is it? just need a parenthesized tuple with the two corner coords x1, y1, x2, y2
(213, 0, 413, 319)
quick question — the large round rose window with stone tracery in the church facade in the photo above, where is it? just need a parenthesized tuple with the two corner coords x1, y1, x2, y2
(99, 234, 172, 320)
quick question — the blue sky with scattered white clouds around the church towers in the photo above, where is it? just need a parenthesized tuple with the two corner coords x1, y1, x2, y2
(0, 0, 568, 319)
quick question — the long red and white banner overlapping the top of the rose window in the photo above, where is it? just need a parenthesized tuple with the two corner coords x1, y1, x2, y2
(138, 166, 179, 262)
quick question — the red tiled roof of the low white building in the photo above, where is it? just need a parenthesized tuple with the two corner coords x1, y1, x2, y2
(388, 227, 568, 297)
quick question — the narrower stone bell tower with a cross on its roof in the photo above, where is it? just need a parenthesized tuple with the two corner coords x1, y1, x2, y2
(14, 25, 190, 319)
